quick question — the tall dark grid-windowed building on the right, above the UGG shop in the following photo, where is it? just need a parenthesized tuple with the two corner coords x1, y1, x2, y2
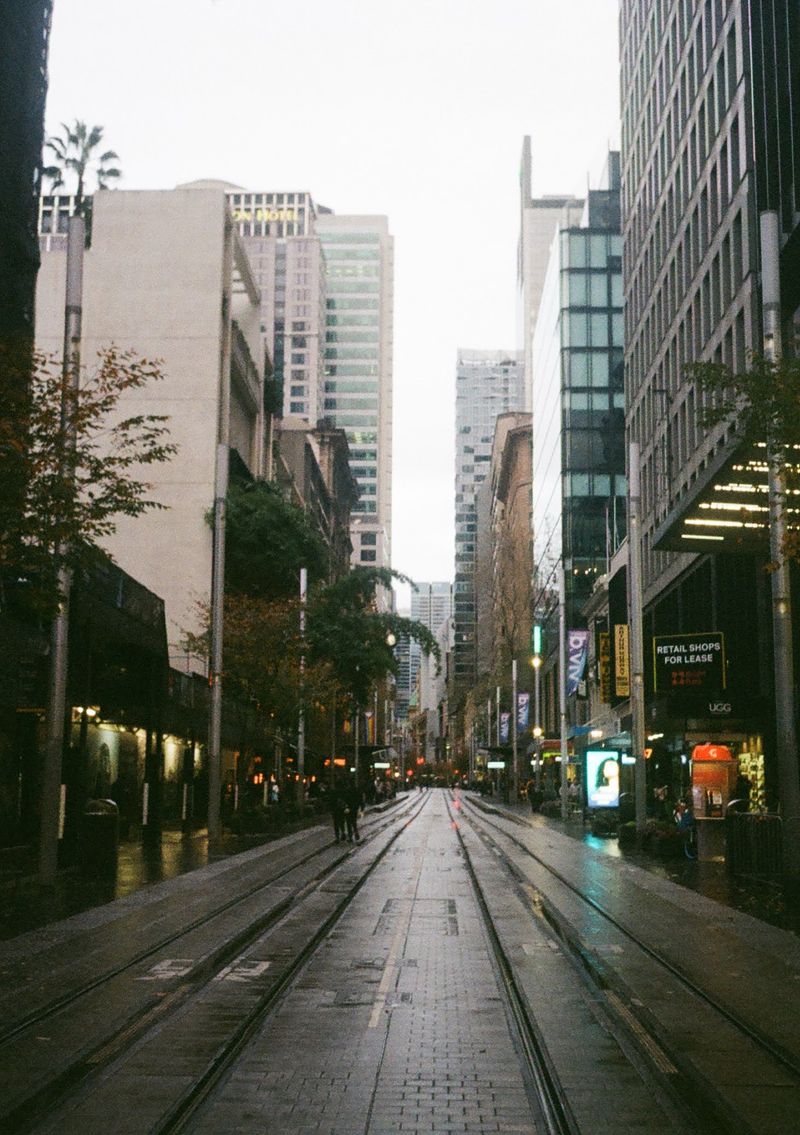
(620, 0, 800, 808)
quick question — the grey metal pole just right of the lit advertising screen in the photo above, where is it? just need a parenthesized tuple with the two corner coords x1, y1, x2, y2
(628, 442, 647, 834)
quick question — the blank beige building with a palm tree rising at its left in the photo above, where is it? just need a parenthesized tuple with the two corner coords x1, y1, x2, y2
(36, 188, 263, 670)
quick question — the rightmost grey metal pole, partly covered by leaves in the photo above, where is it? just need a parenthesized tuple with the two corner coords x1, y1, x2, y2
(760, 211, 800, 884)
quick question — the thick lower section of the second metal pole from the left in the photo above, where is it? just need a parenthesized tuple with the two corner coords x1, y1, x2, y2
(209, 444, 228, 843)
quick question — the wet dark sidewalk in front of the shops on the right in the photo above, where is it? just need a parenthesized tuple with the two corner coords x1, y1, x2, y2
(481, 797, 800, 934)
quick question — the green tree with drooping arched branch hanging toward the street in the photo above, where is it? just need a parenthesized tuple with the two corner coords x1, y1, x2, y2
(308, 568, 439, 705)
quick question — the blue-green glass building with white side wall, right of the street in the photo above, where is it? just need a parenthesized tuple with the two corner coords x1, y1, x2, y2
(532, 153, 626, 627)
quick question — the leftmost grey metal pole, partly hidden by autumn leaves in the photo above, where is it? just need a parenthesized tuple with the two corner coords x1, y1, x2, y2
(39, 217, 86, 885)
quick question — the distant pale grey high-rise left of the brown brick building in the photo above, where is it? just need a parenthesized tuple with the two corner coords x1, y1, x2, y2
(453, 350, 524, 690)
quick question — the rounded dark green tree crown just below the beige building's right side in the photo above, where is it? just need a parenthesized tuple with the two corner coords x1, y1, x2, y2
(225, 481, 328, 599)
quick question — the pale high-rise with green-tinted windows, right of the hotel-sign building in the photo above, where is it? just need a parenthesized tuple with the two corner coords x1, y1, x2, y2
(315, 213, 394, 568)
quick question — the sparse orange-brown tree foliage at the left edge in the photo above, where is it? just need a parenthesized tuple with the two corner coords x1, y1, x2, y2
(0, 346, 176, 615)
